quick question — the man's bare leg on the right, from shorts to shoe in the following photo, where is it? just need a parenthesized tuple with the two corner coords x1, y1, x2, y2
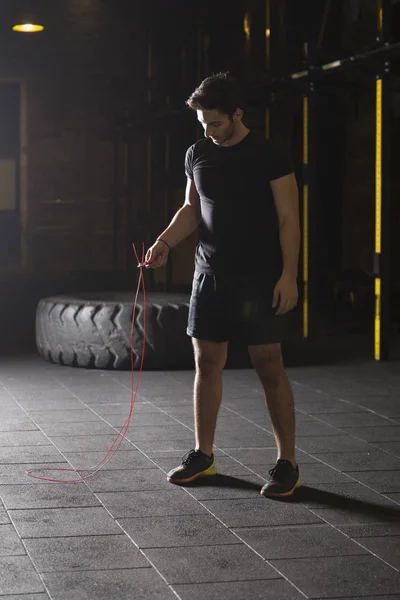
(249, 344, 296, 467)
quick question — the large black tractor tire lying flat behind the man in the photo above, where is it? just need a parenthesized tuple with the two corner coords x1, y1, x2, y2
(36, 292, 194, 370)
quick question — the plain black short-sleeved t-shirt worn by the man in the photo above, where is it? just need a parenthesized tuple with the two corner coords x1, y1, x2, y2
(185, 131, 293, 282)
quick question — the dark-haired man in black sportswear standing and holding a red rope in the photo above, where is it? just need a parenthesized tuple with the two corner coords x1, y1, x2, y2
(146, 73, 300, 496)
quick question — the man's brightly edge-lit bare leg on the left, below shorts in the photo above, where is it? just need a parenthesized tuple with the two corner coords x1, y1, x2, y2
(193, 339, 228, 456)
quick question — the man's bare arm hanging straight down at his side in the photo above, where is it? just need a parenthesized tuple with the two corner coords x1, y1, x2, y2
(270, 173, 300, 315)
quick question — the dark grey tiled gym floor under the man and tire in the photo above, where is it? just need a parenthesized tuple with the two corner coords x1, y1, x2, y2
(0, 356, 400, 600)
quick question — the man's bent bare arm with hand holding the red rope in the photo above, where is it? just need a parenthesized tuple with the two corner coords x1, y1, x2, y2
(146, 177, 201, 269)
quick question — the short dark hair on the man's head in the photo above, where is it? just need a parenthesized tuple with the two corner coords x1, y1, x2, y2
(186, 72, 244, 117)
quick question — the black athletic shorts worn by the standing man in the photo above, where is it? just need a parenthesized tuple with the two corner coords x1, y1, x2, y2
(187, 271, 291, 346)
